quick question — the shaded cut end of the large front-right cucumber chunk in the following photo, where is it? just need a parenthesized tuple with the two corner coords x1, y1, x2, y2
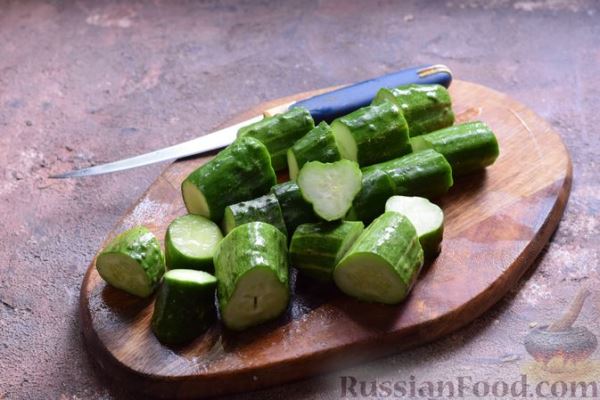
(333, 253, 409, 304)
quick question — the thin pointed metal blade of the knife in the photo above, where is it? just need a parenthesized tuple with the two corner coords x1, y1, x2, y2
(50, 115, 262, 179)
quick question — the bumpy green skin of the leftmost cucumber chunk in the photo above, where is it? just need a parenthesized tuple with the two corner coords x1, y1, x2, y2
(96, 226, 165, 297)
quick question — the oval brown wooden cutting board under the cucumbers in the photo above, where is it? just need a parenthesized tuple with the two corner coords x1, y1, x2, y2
(80, 81, 571, 397)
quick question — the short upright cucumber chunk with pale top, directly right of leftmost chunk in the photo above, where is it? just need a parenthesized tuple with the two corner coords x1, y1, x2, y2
(165, 214, 223, 272)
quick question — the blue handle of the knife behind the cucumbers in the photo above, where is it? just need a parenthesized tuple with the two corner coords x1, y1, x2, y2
(291, 64, 452, 123)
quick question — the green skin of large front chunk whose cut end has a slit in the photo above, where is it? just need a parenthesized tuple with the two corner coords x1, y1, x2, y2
(214, 222, 289, 325)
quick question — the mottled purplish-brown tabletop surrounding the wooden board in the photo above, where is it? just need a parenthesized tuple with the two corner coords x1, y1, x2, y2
(0, 0, 600, 399)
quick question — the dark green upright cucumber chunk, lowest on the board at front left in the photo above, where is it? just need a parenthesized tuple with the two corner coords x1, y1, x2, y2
(151, 269, 217, 345)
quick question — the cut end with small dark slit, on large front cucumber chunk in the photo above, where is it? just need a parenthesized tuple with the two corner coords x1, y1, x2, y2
(222, 267, 289, 330)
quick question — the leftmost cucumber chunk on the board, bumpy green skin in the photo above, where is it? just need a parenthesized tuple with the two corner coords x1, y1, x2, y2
(96, 226, 165, 297)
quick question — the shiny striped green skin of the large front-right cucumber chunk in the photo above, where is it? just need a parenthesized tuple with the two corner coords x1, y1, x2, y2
(334, 211, 424, 304)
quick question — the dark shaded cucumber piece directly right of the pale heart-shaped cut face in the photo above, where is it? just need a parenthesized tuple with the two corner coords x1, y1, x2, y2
(346, 169, 396, 224)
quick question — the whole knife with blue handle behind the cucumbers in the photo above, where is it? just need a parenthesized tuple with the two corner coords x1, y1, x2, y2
(50, 64, 452, 178)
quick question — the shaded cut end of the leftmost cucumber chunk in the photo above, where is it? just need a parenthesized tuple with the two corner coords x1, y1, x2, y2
(96, 253, 154, 297)
